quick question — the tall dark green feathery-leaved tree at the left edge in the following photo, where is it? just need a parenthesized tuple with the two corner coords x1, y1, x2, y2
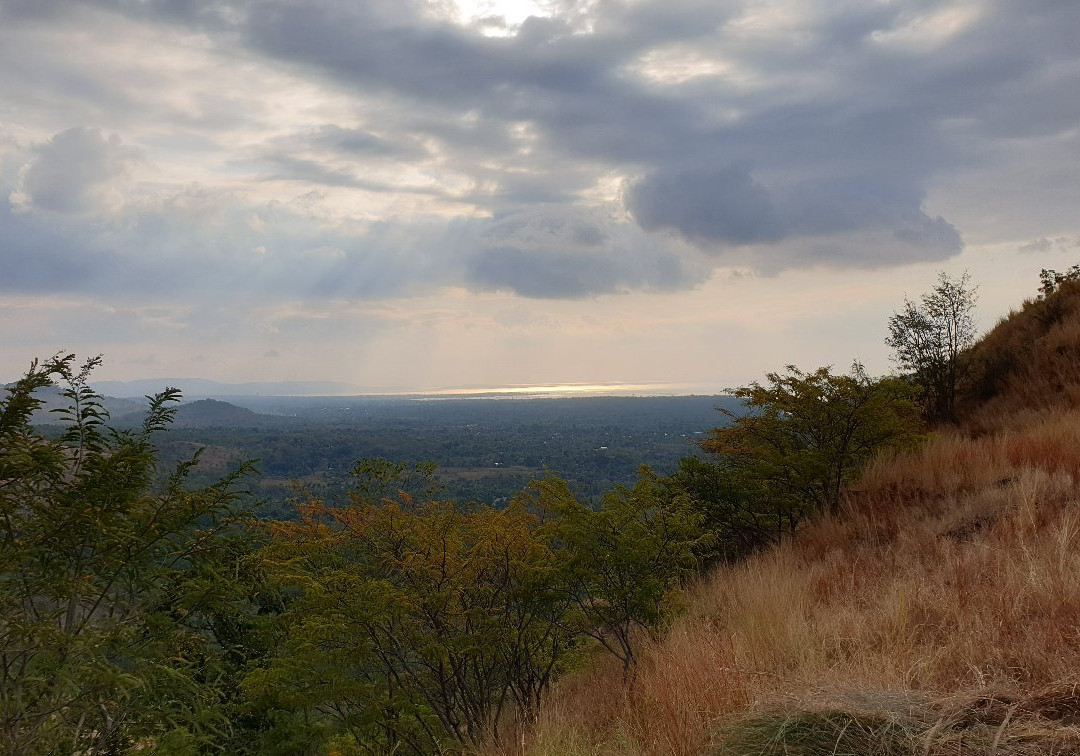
(0, 354, 259, 754)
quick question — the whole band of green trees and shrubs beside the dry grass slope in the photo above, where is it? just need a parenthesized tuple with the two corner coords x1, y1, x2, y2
(0, 347, 937, 754)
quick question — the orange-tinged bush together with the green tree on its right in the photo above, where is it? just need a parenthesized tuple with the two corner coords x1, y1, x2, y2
(251, 462, 704, 753)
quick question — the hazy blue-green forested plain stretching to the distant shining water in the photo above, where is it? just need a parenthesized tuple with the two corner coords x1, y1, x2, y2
(107, 395, 741, 517)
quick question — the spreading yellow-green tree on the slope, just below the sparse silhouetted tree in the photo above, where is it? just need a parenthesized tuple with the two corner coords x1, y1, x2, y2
(701, 363, 919, 520)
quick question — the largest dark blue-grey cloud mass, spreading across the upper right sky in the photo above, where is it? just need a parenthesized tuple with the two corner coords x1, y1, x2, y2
(225, 2, 1080, 272)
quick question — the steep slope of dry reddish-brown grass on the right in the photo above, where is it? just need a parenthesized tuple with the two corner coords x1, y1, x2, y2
(505, 282, 1080, 756)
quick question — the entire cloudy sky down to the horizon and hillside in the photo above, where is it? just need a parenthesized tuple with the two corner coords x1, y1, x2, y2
(0, 0, 1080, 393)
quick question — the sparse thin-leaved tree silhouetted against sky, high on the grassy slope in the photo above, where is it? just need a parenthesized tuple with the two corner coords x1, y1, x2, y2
(886, 272, 977, 421)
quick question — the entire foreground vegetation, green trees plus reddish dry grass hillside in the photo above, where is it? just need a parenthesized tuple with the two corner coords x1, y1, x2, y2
(0, 273, 1080, 756)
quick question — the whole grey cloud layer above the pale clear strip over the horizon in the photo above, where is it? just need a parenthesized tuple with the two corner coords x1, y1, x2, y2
(0, 0, 1080, 386)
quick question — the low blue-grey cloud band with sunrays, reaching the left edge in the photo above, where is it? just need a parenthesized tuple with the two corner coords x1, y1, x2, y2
(0, 134, 708, 302)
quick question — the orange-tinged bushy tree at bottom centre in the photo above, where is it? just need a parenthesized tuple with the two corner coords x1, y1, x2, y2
(246, 481, 573, 753)
